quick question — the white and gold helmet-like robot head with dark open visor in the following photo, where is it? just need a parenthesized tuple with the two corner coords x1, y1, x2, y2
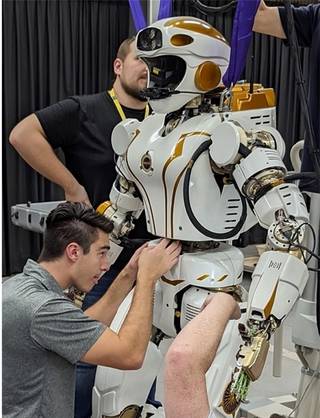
(136, 16, 230, 113)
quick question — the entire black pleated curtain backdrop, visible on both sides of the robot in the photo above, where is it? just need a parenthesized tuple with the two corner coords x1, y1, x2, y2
(2, 0, 311, 274)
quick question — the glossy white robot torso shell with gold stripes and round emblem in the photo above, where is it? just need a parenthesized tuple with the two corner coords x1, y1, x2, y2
(126, 115, 242, 241)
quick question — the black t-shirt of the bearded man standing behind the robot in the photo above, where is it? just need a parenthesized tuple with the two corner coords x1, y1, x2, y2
(35, 92, 152, 268)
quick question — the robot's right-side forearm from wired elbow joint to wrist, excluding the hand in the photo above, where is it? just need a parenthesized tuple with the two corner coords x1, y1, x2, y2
(247, 203, 308, 336)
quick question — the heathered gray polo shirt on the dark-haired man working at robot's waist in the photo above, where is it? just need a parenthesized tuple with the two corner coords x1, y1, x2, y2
(2, 260, 105, 418)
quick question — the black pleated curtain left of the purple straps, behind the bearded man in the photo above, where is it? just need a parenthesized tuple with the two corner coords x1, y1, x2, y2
(2, 0, 130, 275)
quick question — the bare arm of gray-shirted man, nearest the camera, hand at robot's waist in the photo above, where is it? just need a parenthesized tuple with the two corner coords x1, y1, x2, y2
(81, 239, 181, 370)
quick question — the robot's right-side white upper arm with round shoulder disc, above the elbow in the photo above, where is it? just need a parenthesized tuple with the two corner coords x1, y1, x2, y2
(210, 120, 308, 228)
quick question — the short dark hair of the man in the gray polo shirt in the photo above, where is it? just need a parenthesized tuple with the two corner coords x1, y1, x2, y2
(38, 202, 113, 262)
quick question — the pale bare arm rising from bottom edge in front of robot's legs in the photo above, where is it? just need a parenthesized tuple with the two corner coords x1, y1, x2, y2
(164, 293, 240, 418)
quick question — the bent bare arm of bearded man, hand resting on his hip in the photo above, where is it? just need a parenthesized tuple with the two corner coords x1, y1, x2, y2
(9, 114, 91, 206)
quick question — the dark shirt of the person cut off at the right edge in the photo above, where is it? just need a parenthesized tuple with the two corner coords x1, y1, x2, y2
(279, 4, 320, 193)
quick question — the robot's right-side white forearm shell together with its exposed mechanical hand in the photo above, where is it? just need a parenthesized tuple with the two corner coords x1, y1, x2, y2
(222, 247, 308, 413)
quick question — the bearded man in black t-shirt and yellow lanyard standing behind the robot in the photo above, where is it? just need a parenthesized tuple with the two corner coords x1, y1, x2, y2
(9, 38, 154, 418)
